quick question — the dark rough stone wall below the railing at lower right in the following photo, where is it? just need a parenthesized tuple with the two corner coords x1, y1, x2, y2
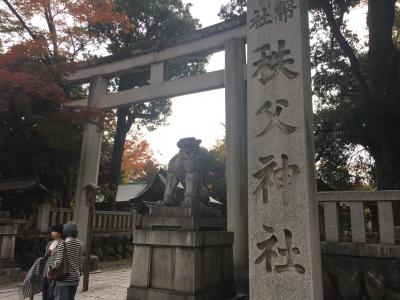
(322, 254, 400, 300)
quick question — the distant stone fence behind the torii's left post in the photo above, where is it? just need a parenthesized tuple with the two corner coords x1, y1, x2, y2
(36, 204, 136, 233)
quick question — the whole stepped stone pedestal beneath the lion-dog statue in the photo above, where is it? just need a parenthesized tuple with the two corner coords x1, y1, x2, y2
(127, 207, 236, 300)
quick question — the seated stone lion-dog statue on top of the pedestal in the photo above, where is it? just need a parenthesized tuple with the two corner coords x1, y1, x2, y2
(160, 137, 210, 208)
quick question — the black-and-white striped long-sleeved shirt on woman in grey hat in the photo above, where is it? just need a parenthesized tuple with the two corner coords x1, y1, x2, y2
(50, 238, 84, 286)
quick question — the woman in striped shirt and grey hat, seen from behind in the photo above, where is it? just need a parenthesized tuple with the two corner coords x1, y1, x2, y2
(49, 222, 84, 300)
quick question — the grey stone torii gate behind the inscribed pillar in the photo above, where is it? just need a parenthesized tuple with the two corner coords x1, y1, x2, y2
(68, 18, 248, 289)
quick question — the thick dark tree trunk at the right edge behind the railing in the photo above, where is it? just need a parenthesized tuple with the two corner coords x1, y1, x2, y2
(368, 0, 400, 226)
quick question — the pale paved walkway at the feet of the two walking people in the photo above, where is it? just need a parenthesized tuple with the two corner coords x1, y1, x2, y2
(0, 267, 131, 300)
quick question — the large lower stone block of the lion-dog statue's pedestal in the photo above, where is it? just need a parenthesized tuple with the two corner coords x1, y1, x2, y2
(128, 230, 236, 300)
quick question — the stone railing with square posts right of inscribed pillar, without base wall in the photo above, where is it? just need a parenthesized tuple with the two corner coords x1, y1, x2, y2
(317, 191, 400, 257)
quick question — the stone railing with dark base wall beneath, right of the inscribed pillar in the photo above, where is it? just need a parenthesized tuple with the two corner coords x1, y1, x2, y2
(317, 191, 400, 300)
